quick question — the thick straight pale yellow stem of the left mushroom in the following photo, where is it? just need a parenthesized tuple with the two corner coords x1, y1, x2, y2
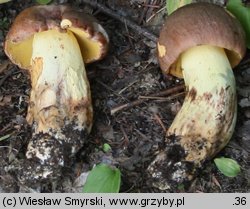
(26, 29, 92, 164)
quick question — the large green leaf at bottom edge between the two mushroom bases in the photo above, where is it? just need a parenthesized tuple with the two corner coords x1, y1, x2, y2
(83, 163, 121, 193)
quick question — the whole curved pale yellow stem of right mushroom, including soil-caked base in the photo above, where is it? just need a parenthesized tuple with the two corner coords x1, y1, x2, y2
(149, 45, 237, 189)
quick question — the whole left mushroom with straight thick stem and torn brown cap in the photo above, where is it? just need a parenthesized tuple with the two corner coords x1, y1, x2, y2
(4, 5, 109, 179)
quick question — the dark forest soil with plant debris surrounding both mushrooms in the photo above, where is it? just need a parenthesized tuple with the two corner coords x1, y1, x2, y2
(0, 0, 250, 192)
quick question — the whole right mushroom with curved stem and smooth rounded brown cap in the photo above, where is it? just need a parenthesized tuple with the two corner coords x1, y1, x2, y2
(148, 3, 246, 190)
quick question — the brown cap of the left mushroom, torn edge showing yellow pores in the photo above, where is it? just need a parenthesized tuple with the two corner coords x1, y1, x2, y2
(4, 5, 109, 69)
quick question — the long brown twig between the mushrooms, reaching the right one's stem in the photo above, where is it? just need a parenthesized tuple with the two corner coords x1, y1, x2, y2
(110, 85, 185, 115)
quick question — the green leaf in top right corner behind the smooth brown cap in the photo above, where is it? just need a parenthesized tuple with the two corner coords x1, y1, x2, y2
(227, 0, 250, 49)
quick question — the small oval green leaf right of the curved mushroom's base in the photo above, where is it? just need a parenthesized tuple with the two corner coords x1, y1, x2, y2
(214, 157, 240, 177)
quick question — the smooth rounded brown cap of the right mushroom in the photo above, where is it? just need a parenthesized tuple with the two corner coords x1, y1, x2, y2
(158, 2, 246, 78)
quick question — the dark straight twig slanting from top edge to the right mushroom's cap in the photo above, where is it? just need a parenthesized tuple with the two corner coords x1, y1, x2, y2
(82, 0, 157, 42)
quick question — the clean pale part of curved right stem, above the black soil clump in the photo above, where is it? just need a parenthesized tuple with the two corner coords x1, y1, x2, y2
(167, 45, 237, 164)
